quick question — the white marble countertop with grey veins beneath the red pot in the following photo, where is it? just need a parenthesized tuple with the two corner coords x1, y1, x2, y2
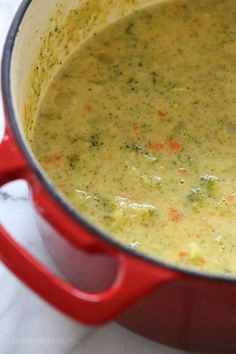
(0, 0, 188, 354)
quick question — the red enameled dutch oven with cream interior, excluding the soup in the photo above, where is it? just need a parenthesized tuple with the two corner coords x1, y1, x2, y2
(0, 0, 236, 354)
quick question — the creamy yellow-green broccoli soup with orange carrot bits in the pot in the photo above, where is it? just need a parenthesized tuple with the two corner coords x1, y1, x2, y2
(32, 0, 236, 274)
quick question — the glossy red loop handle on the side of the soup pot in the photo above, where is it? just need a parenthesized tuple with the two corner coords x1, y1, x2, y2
(0, 128, 176, 324)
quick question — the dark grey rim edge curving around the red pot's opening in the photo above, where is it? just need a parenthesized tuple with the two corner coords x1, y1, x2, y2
(1, 0, 236, 283)
